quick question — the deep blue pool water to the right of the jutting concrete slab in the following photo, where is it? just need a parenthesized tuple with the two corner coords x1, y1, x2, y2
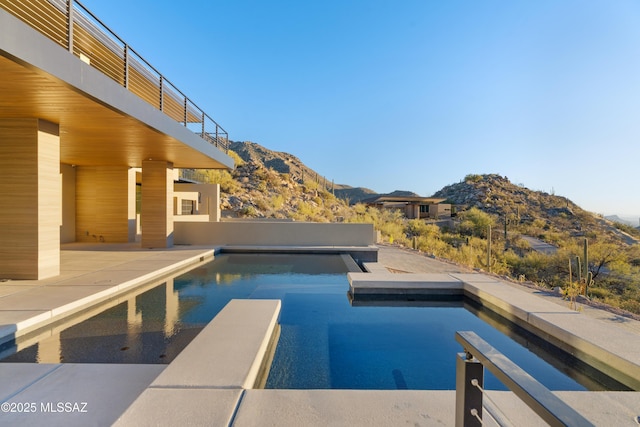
(266, 284, 591, 390)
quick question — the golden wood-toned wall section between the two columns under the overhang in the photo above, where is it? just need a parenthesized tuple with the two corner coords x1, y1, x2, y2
(75, 166, 135, 243)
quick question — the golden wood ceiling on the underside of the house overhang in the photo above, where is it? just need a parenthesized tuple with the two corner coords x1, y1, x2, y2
(0, 55, 230, 169)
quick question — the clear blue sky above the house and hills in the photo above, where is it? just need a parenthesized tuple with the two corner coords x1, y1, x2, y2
(82, 0, 640, 218)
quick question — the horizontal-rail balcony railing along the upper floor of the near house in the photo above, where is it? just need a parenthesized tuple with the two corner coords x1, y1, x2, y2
(0, 0, 229, 152)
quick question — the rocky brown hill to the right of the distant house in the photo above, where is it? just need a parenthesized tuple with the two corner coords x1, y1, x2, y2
(433, 174, 628, 243)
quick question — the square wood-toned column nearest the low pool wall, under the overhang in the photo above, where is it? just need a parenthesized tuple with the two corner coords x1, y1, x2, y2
(140, 160, 173, 248)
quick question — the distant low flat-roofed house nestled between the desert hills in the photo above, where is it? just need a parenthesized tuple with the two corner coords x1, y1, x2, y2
(362, 196, 451, 219)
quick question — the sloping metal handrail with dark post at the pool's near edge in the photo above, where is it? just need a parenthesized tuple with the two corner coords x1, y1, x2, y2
(456, 331, 593, 426)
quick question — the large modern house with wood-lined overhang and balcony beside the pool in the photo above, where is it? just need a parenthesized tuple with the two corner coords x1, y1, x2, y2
(0, 0, 233, 279)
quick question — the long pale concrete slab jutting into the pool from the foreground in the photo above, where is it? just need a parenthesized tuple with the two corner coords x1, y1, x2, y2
(116, 300, 281, 426)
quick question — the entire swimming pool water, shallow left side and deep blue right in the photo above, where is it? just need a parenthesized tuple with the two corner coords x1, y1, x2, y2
(0, 254, 624, 390)
